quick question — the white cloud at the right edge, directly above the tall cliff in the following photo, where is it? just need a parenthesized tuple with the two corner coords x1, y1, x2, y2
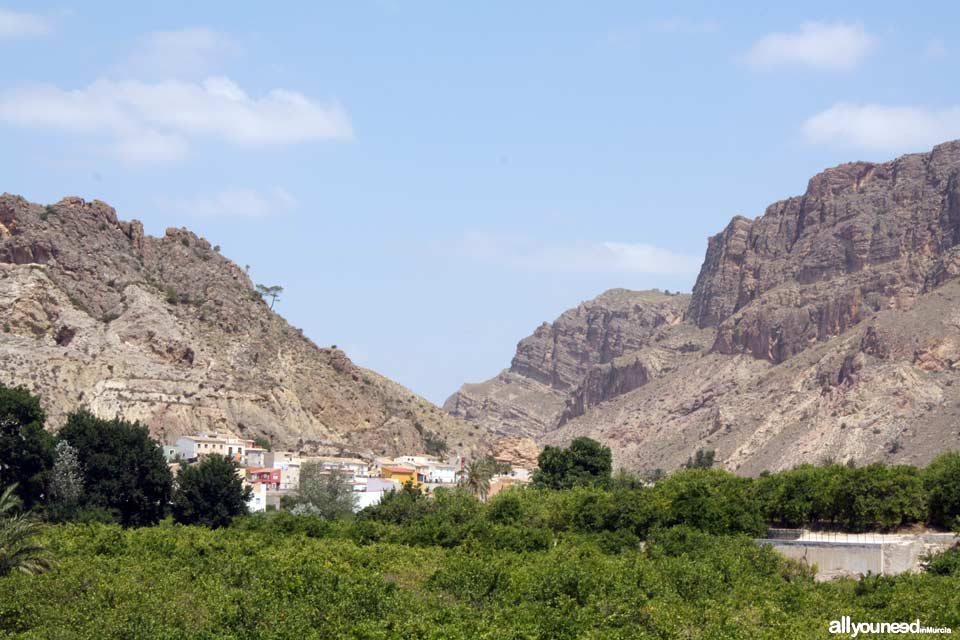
(803, 103, 960, 151)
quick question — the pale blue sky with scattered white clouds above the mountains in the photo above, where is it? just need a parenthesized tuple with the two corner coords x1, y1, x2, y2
(0, 0, 960, 402)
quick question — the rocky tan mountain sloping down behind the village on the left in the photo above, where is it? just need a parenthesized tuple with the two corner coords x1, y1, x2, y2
(0, 194, 481, 454)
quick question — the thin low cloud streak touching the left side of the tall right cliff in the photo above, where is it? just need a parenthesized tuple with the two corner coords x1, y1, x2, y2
(456, 232, 701, 275)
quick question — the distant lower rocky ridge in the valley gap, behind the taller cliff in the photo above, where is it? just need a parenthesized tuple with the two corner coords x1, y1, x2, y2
(444, 289, 709, 438)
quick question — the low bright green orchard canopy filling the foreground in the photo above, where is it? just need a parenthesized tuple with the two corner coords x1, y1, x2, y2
(0, 512, 960, 640)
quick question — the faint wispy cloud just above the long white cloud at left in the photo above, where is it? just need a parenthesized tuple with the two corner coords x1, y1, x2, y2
(119, 27, 240, 79)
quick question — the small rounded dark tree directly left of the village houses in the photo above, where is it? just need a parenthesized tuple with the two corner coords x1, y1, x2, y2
(173, 454, 252, 529)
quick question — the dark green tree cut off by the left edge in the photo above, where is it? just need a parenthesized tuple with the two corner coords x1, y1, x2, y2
(0, 385, 54, 509)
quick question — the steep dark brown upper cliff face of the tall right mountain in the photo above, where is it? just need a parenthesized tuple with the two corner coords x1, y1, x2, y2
(688, 143, 960, 362)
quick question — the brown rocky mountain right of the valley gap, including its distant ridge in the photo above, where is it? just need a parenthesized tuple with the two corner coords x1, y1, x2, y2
(444, 142, 960, 473)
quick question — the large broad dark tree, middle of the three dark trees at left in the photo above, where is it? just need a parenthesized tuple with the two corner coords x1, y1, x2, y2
(58, 409, 172, 527)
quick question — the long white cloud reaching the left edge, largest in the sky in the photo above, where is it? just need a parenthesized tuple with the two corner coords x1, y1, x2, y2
(0, 77, 352, 162)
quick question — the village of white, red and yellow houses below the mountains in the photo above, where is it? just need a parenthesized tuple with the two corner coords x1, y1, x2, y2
(163, 432, 532, 512)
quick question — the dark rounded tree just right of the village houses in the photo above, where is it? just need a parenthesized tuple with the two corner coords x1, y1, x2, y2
(533, 438, 613, 489)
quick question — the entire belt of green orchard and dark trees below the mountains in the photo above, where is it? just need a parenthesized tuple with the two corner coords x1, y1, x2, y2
(0, 389, 960, 640)
